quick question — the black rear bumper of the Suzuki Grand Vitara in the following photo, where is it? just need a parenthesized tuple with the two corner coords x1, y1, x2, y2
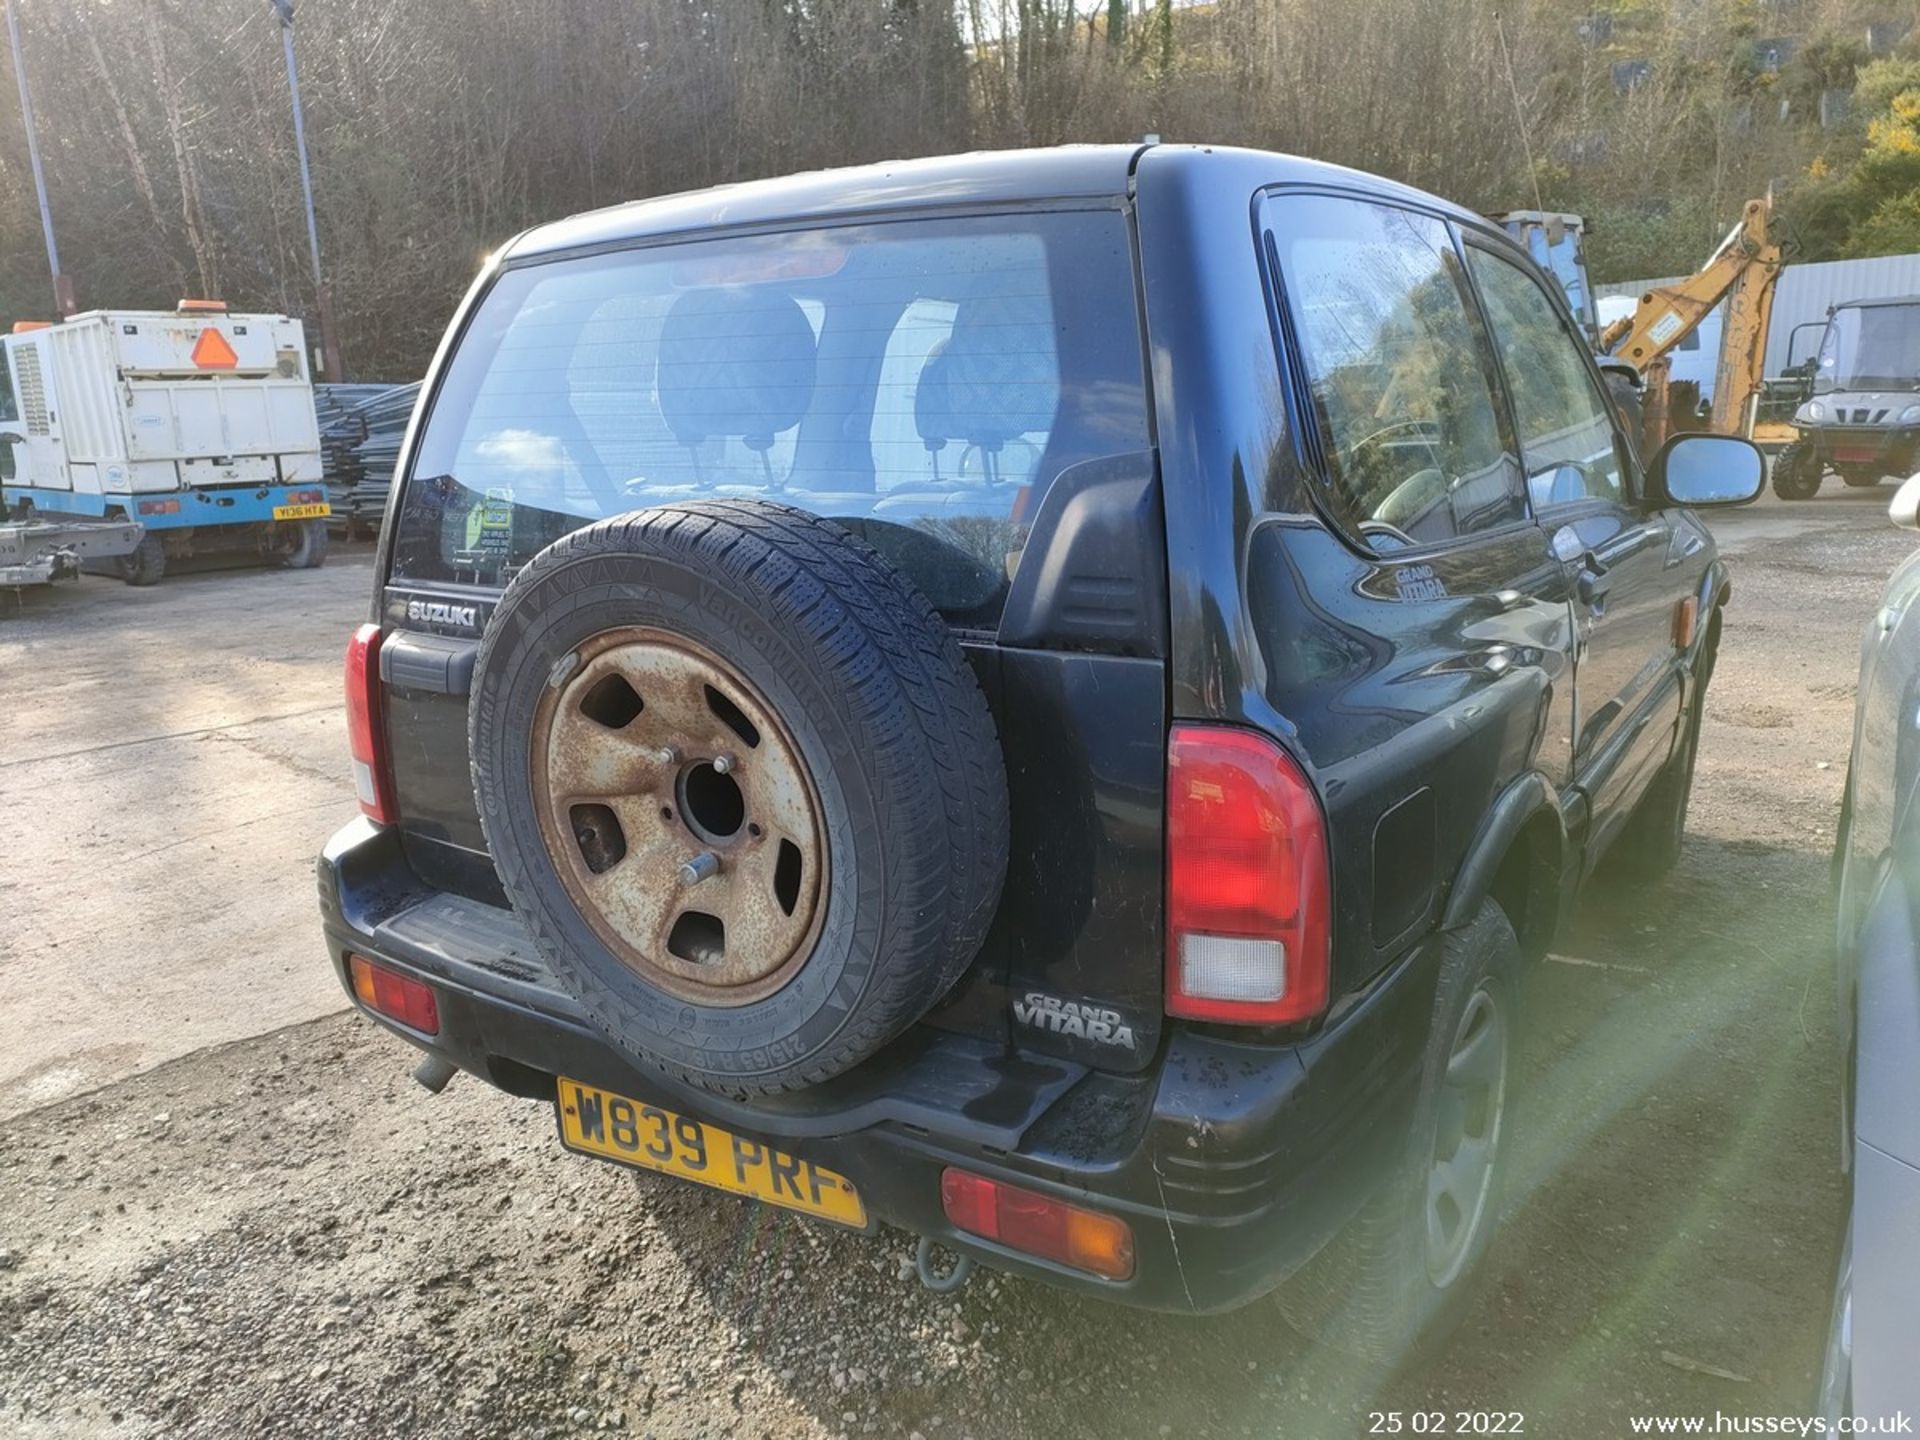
(319, 820, 1434, 1311)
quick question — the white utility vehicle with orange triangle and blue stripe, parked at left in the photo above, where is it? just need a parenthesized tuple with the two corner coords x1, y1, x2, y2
(0, 300, 328, 586)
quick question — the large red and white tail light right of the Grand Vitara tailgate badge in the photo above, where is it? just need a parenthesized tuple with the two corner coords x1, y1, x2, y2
(1167, 726, 1332, 1025)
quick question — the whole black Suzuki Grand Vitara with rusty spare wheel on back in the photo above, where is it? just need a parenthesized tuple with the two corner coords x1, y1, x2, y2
(319, 146, 1761, 1348)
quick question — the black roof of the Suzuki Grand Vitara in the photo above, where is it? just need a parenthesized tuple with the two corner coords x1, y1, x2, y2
(501, 144, 1486, 261)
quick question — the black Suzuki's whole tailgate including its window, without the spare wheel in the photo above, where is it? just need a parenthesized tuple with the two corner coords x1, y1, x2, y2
(366, 196, 1167, 1069)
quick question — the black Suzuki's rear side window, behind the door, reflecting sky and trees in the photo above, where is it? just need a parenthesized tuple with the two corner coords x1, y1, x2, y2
(1265, 194, 1526, 551)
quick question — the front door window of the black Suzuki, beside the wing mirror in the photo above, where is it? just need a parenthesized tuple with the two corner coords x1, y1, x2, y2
(1467, 244, 1626, 511)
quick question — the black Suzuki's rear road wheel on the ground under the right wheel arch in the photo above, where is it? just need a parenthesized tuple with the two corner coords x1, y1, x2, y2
(1281, 900, 1521, 1363)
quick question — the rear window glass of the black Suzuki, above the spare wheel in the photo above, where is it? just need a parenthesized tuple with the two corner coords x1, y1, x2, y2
(394, 211, 1148, 626)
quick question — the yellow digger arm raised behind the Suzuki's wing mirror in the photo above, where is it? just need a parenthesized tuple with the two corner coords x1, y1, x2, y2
(1599, 196, 1780, 434)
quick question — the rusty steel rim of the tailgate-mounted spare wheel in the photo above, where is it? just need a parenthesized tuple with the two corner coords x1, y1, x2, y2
(530, 626, 828, 1006)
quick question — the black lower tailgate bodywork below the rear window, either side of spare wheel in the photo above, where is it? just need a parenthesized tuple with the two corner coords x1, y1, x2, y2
(368, 586, 1165, 1069)
